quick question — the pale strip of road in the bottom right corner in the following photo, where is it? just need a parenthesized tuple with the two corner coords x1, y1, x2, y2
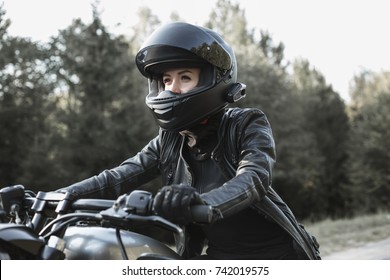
(322, 238, 390, 260)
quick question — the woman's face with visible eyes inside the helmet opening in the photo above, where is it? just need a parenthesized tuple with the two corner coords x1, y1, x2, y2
(163, 68, 200, 94)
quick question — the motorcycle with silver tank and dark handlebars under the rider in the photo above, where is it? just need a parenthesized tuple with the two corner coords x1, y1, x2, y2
(0, 185, 212, 260)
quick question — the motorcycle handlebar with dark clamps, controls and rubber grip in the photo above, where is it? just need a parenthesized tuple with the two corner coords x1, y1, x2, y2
(0, 186, 213, 236)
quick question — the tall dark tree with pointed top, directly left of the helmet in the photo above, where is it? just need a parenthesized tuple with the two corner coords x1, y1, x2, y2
(52, 7, 155, 185)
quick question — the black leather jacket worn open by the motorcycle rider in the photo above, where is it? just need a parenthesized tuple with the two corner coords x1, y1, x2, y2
(61, 108, 320, 259)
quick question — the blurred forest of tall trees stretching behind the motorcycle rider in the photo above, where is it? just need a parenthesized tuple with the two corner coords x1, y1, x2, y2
(0, 0, 390, 221)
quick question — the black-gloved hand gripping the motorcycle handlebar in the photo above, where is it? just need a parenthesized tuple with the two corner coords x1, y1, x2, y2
(153, 184, 204, 225)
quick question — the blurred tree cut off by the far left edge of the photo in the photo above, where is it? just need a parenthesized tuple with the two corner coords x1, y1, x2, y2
(0, 8, 56, 190)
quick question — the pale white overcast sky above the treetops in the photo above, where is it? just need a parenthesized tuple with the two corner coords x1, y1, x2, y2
(0, 0, 390, 102)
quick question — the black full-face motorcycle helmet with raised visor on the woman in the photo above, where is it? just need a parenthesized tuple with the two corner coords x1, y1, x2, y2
(136, 22, 245, 131)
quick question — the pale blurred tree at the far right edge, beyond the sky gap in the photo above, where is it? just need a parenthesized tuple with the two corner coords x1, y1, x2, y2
(349, 71, 390, 214)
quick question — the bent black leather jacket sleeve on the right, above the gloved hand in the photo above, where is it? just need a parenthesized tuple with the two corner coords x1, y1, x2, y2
(201, 109, 276, 217)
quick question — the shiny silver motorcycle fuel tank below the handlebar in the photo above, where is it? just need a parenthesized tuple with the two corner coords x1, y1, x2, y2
(63, 226, 181, 260)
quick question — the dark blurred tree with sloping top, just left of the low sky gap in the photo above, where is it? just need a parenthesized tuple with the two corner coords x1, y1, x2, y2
(294, 60, 349, 217)
